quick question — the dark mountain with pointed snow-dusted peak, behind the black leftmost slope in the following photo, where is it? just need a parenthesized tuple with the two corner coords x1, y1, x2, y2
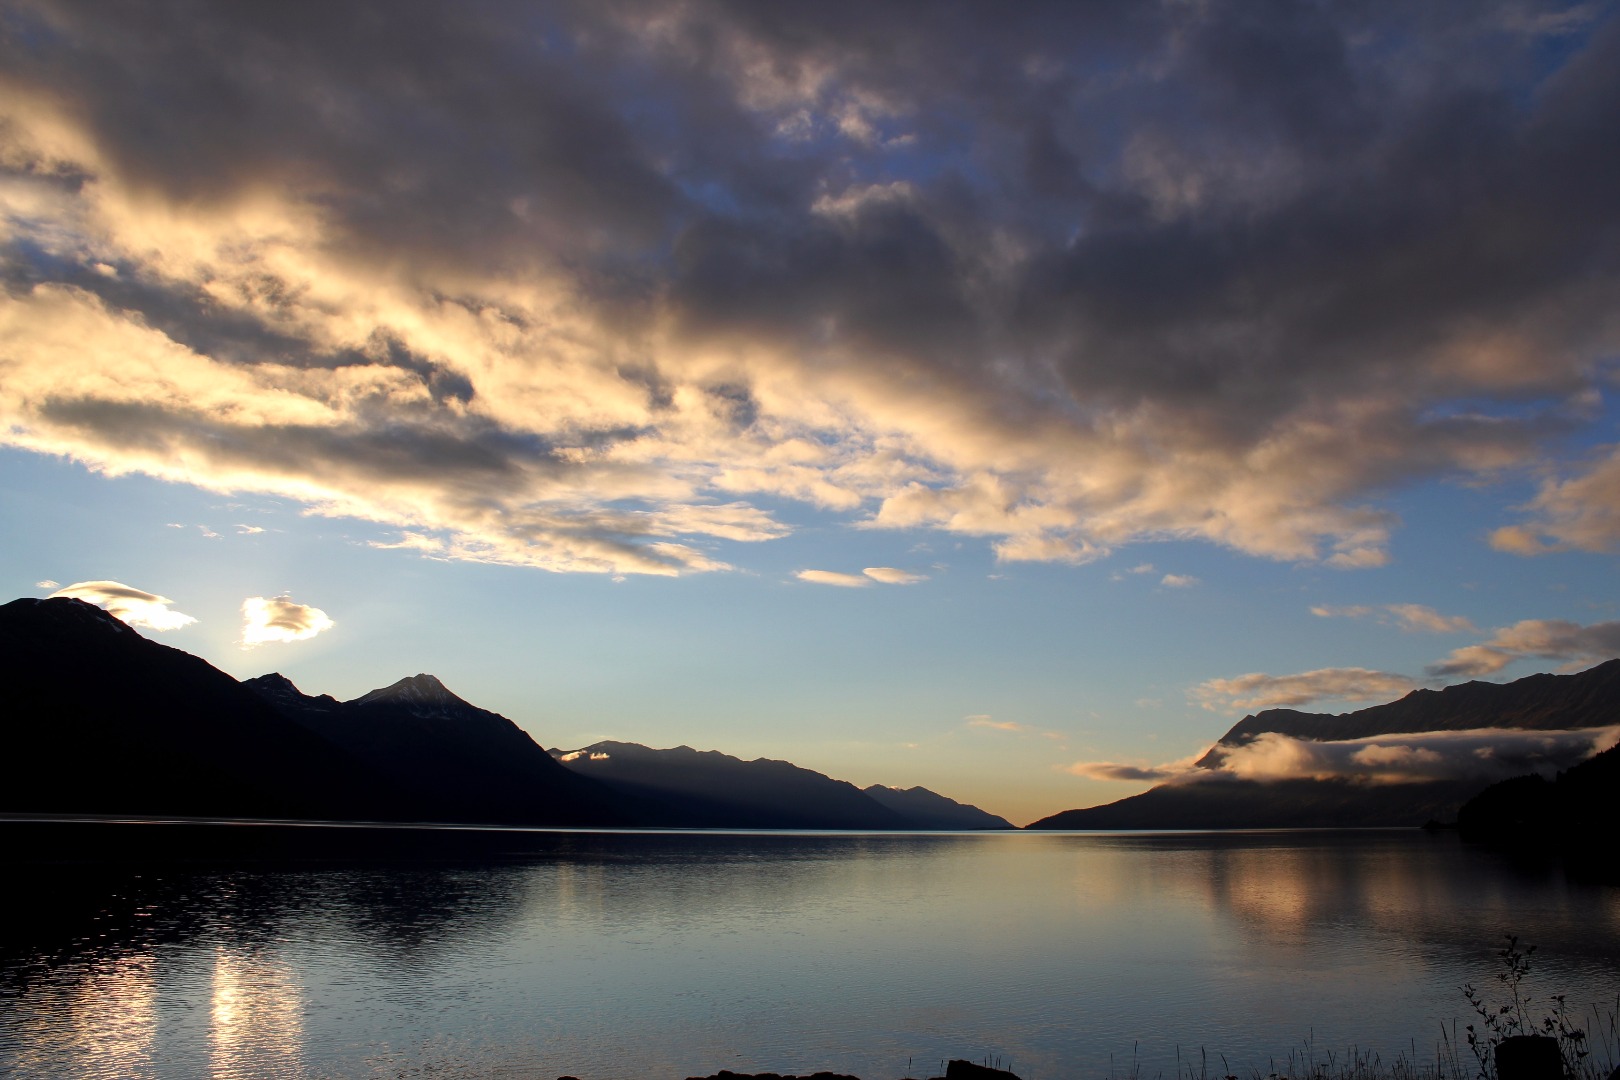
(241, 674, 633, 824)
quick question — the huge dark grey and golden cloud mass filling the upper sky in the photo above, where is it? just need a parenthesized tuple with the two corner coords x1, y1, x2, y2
(0, 0, 1620, 575)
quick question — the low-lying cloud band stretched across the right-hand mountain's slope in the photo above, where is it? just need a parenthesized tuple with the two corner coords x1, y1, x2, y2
(1068, 725, 1620, 784)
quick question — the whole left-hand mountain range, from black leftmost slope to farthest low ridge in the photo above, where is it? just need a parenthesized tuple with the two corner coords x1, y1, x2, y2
(0, 597, 1013, 829)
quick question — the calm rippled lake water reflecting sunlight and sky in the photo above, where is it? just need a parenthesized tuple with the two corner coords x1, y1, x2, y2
(0, 826, 1620, 1080)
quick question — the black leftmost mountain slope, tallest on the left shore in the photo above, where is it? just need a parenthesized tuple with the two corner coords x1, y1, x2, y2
(0, 597, 410, 819)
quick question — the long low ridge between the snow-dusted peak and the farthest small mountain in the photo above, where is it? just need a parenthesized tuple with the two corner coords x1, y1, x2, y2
(552, 742, 917, 829)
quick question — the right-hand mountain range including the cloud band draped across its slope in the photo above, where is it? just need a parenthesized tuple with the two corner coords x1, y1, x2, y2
(1025, 661, 1620, 832)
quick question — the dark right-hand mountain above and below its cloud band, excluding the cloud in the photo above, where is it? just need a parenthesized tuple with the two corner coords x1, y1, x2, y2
(1025, 659, 1620, 829)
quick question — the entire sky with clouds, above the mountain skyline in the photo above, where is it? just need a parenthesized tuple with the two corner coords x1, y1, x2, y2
(0, 0, 1620, 824)
